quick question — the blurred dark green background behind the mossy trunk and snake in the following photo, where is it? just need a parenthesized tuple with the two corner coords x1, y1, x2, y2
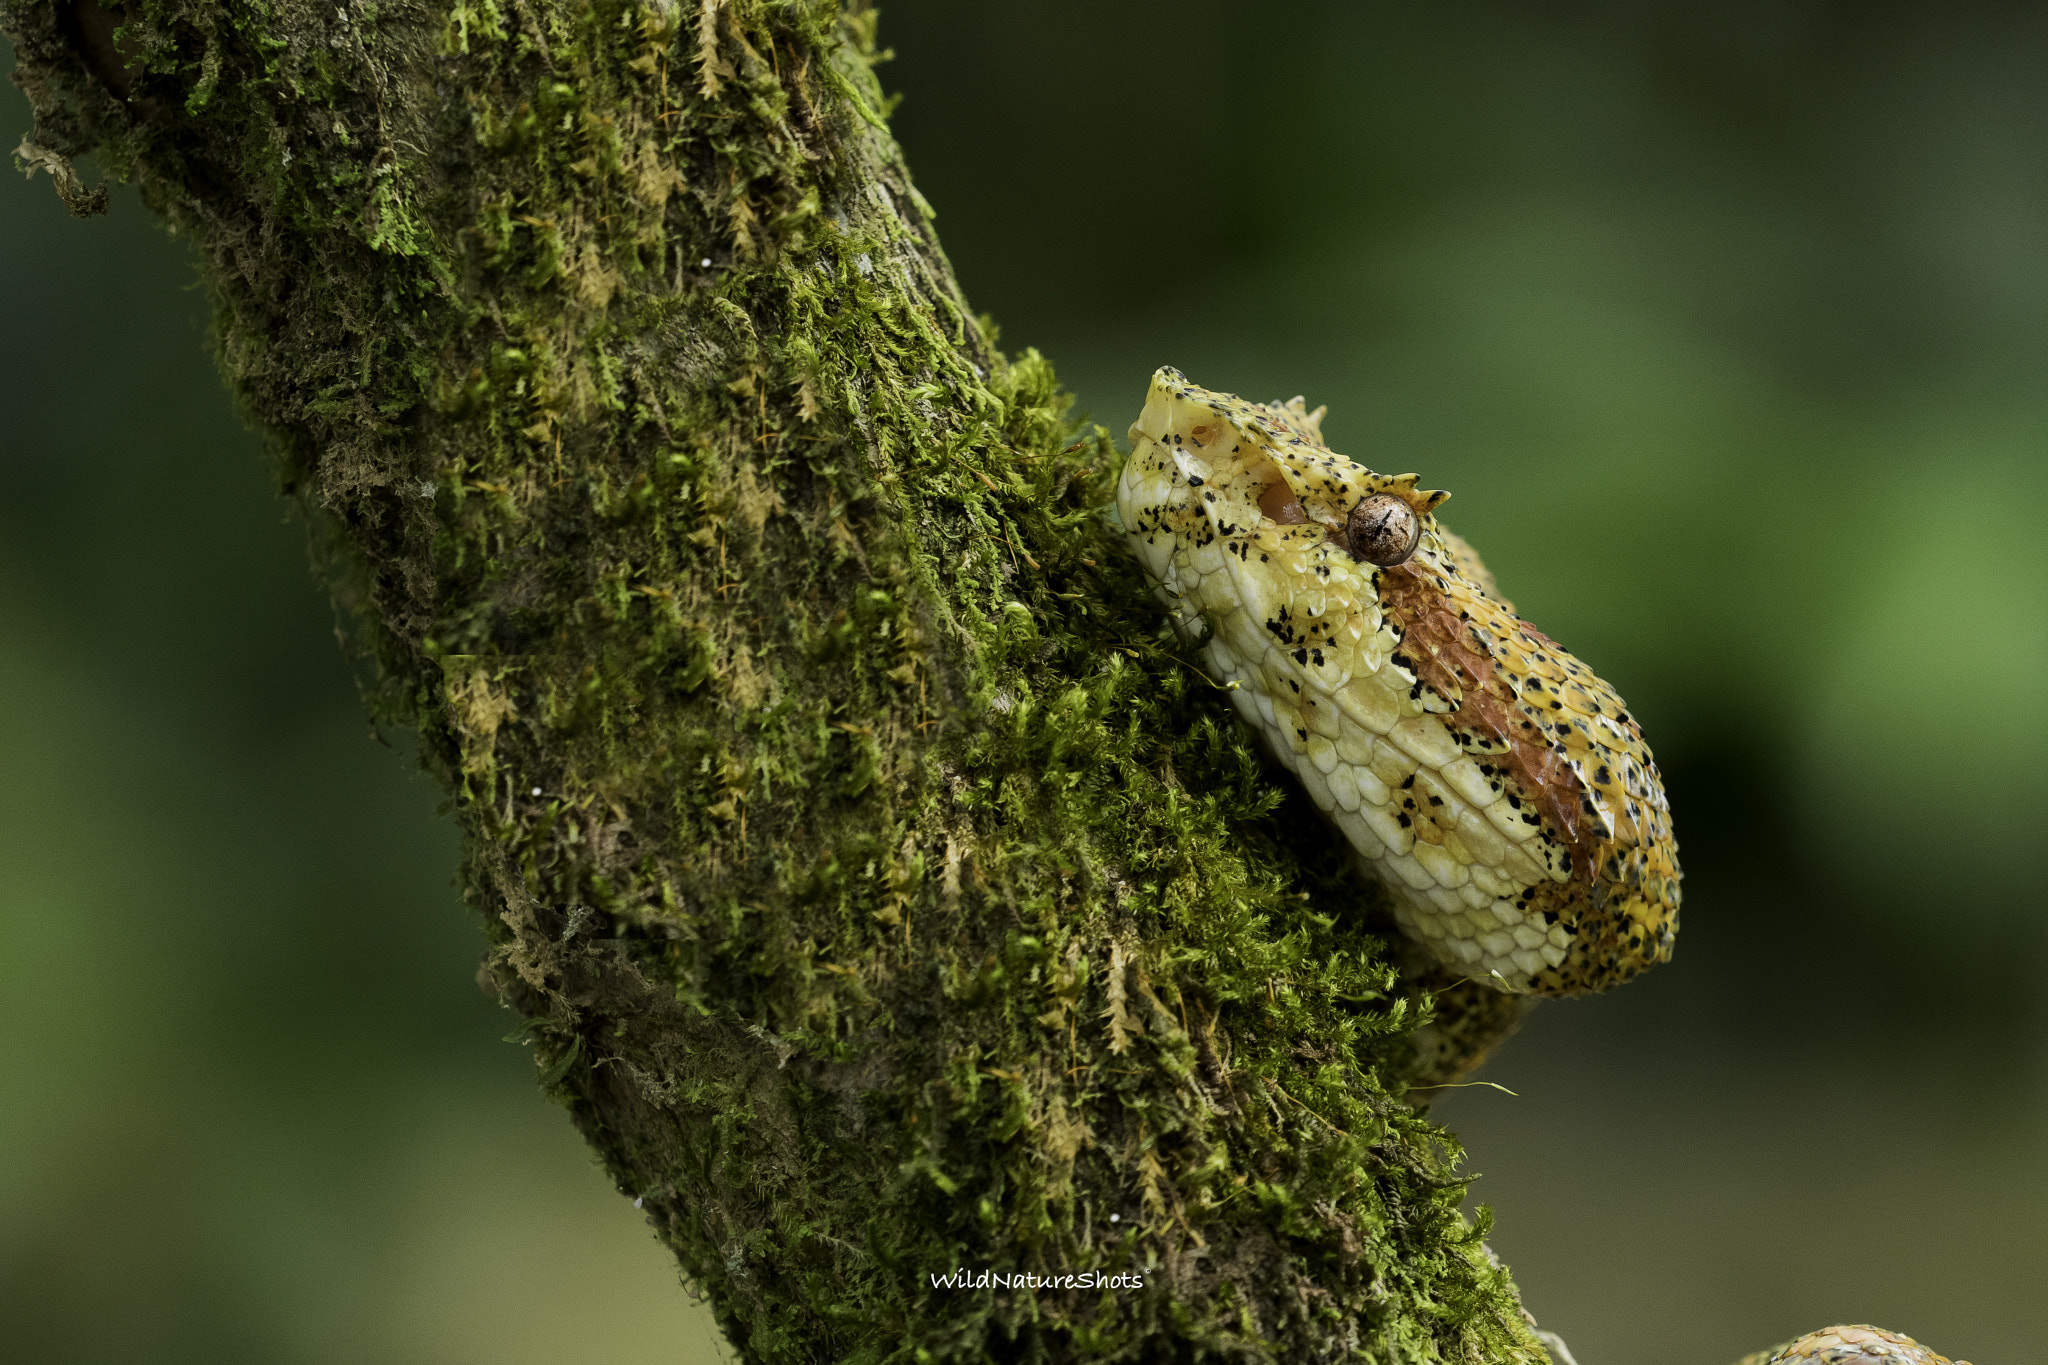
(0, 0, 2048, 1365)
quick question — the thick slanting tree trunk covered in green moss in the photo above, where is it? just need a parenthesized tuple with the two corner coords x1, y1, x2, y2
(0, 0, 1542, 1361)
